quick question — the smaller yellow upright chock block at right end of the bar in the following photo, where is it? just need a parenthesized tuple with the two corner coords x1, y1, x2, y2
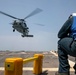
(33, 54, 43, 75)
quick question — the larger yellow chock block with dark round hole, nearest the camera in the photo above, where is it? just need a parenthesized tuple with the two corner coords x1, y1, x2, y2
(5, 58, 23, 75)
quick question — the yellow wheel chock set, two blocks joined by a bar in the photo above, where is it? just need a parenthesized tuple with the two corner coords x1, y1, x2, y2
(5, 54, 43, 75)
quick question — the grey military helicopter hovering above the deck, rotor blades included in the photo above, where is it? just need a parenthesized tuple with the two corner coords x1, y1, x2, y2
(0, 8, 42, 37)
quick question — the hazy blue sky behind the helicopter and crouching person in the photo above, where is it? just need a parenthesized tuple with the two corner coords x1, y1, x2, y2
(0, 0, 76, 51)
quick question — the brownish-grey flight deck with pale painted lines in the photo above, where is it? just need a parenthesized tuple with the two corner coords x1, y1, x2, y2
(0, 51, 75, 75)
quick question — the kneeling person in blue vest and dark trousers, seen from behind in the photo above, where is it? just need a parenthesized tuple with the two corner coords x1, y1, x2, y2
(55, 13, 76, 75)
